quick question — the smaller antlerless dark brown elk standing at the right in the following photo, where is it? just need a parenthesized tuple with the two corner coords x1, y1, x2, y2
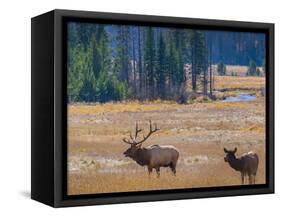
(224, 148, 259, 184)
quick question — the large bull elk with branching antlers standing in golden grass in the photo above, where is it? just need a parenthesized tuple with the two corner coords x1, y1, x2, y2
(123, 120, 179, 177)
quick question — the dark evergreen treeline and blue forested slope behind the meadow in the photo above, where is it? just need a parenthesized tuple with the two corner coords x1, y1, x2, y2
(67, 23, 264, 103)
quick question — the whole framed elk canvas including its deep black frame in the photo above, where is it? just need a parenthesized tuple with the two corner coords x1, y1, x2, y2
(31, 10, 274, 207)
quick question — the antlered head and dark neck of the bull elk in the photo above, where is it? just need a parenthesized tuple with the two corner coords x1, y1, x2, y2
(123, 120, 159, 158)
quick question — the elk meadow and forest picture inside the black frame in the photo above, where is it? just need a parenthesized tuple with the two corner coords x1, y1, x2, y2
(66, 21, 267, 195)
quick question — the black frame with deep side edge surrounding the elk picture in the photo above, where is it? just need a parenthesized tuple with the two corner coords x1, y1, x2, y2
(31, 10, 274, 207)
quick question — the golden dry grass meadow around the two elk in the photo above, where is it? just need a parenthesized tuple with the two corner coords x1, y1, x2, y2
(68, 76, 265, 195)
